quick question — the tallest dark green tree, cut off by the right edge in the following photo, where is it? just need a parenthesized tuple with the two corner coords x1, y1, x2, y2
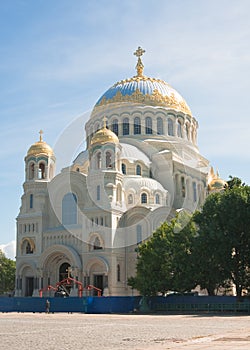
(192, 178, 250, 296)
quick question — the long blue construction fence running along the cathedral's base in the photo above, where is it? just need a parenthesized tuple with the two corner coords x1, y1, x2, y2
(0, 295, 250, 314)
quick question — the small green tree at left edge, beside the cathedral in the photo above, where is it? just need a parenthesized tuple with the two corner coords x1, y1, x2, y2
(0, 250, 16, 295)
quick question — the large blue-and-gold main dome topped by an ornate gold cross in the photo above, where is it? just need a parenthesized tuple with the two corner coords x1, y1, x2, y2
(95, 47, 191, 115)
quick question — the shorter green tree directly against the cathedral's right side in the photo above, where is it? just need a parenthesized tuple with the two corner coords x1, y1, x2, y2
(128, 213, 196, 296)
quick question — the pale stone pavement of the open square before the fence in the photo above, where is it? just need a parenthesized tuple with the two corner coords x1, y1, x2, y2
(0, 313, 250, 350)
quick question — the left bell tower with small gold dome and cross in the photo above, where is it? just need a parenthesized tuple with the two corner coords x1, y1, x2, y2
(16, 131, 55, 296)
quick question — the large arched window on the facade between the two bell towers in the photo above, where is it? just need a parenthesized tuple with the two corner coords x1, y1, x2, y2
(62, 192, 77, 225)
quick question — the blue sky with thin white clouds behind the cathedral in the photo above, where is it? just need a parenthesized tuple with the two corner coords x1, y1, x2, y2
(0, 0, 250, 257)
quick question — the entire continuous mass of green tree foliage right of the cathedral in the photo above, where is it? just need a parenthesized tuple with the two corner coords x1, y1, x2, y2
(129, 177, 250, 296)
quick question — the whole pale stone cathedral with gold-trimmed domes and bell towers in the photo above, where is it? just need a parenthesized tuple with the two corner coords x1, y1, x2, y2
(15, 47, 224, 296)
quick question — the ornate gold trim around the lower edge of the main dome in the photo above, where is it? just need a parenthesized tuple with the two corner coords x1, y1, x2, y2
(96, 88, 191, 115)
